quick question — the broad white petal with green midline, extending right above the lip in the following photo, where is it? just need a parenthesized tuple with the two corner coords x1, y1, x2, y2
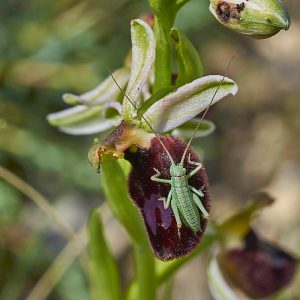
(141, 75, 238, 132)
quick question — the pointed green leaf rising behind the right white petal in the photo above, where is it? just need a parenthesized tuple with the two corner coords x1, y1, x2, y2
(171, 28, 203, 86)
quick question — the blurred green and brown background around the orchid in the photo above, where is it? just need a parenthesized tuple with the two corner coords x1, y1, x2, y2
(0, 0, 300, 300)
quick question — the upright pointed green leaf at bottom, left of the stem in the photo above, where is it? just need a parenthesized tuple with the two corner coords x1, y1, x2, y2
(88, 209, 121, 300)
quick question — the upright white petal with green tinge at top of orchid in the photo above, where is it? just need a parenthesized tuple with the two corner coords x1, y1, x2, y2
(122, 19, 155, 120)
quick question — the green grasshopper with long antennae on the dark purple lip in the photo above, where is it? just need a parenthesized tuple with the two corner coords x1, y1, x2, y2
(111, 63, 231, 237)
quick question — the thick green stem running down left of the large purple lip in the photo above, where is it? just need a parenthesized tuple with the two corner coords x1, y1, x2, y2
(101, 161, 156, 300)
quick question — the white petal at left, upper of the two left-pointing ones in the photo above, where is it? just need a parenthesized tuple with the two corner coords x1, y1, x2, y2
(63, 67, 130, 106)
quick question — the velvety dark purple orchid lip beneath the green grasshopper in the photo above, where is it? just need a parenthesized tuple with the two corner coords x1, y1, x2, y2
(124, 136, 210, 260)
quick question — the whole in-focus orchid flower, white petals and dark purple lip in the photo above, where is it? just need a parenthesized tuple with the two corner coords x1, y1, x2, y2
(48, 19, 238, 260)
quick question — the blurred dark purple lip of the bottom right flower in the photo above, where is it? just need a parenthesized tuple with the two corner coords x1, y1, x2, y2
(218, 230, 297, 299)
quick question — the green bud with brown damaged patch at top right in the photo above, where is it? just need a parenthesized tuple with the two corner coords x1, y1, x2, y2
(209, 0, 290, 38)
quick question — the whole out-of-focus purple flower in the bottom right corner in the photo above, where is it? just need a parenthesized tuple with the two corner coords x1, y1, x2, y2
(208, 193, 297, 300)
